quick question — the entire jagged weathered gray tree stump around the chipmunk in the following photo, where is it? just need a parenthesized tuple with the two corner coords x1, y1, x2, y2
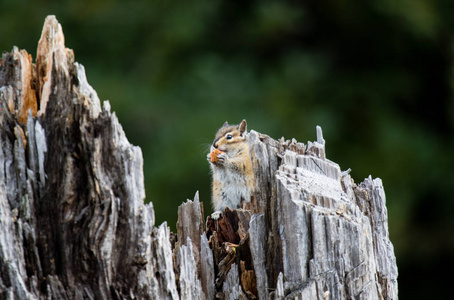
(0, 16, 397, 299)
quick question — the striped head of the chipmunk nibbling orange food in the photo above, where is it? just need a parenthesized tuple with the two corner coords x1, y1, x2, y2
(211, 120, 247, 153)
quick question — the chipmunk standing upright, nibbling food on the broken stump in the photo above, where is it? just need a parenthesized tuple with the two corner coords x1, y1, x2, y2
(207, 120, 255, 219)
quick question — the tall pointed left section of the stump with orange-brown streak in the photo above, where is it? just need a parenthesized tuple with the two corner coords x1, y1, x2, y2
(0, 17, 178, 299)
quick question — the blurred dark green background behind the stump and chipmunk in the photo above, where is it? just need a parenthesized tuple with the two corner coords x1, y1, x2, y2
(0, 0, 454, 299)
